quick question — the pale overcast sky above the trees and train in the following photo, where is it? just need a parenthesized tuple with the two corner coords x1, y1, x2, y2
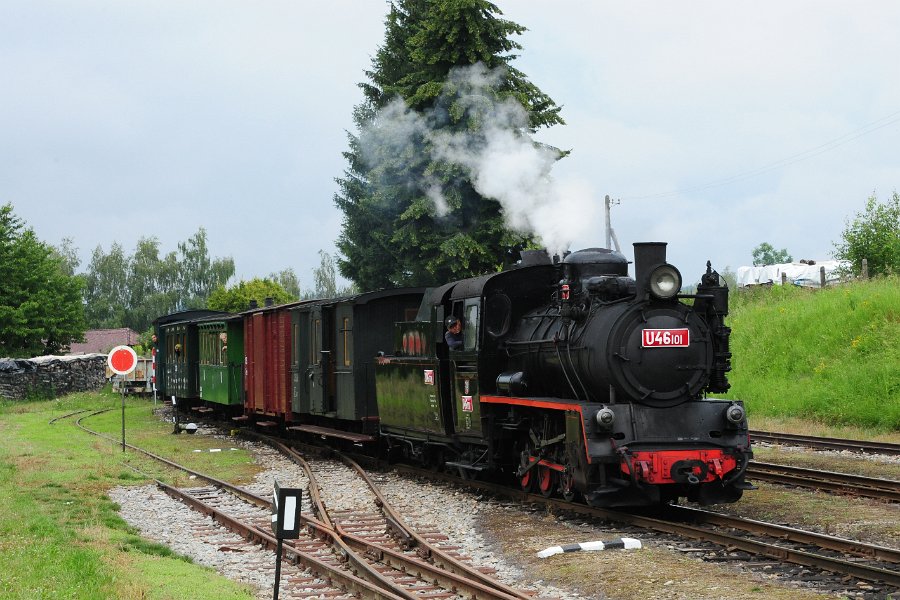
(0, 0, 900, 288)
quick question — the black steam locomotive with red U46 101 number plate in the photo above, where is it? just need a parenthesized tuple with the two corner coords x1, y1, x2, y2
(376, 242, 752, 506)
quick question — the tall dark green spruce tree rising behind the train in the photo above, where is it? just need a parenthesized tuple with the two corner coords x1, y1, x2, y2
(335, 0, 563, 290)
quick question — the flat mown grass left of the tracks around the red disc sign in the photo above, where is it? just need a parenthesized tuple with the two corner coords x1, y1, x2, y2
(0, 391, 255, 600)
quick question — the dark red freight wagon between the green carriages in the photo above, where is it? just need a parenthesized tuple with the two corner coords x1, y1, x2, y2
(243, 302, 300, 421)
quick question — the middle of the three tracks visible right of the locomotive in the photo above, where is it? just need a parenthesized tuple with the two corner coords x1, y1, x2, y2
(747, 461, 900, 502)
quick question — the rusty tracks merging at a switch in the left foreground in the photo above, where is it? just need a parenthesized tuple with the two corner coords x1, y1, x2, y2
(76, 413, 531, 600)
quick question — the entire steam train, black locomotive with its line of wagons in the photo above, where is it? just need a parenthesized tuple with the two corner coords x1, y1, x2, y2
(156, 242, 752, 506)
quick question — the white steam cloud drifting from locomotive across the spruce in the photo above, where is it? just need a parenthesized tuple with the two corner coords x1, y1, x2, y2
(361, 64, 600, 255)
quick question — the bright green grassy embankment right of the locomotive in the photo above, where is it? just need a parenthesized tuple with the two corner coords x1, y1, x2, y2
(727, 277, 900, 432)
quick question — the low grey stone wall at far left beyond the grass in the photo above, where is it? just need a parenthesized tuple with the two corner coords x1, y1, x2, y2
(0, 354, 106, 400)
